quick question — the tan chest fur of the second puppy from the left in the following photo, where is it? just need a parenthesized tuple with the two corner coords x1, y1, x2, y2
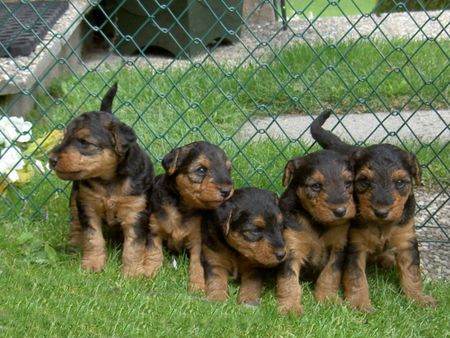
(150, 205, 201, 249)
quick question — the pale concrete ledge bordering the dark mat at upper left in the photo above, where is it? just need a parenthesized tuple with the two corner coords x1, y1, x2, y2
(0, 0, 92, 115)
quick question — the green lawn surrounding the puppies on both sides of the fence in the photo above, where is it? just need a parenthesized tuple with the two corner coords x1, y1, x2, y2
(0, 36, 450, 337)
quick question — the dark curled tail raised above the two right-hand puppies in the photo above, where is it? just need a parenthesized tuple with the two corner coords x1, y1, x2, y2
(310, 109, 355, 153)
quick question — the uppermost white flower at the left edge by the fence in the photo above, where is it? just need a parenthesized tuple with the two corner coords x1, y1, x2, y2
(0, 116, 33, 146)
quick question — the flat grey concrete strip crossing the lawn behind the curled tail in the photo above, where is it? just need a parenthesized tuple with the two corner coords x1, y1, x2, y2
(239, 110, 450, 144)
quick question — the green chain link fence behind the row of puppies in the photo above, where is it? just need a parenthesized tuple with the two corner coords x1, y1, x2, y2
(0, 0, 450, 243)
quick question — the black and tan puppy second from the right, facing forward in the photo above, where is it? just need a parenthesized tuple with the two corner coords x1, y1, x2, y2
(277, 150, 356, 313)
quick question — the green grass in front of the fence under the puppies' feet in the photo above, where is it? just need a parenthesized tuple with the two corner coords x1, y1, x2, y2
(0, 217, 450, 337)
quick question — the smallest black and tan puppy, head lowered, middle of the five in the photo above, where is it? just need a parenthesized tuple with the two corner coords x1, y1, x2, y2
(202, 188, 286, 305)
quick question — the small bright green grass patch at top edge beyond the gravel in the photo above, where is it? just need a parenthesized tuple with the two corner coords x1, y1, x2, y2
(286, 0, 377, 18)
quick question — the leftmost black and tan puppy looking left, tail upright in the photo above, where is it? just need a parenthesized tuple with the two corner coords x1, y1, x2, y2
(49, 84, 154, 276)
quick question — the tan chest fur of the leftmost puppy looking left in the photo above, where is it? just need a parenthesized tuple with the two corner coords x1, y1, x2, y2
(80, 181, 146, 226)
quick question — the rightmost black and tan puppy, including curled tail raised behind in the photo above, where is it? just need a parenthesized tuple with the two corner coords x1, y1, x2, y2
(311, 110, 435, 311)
